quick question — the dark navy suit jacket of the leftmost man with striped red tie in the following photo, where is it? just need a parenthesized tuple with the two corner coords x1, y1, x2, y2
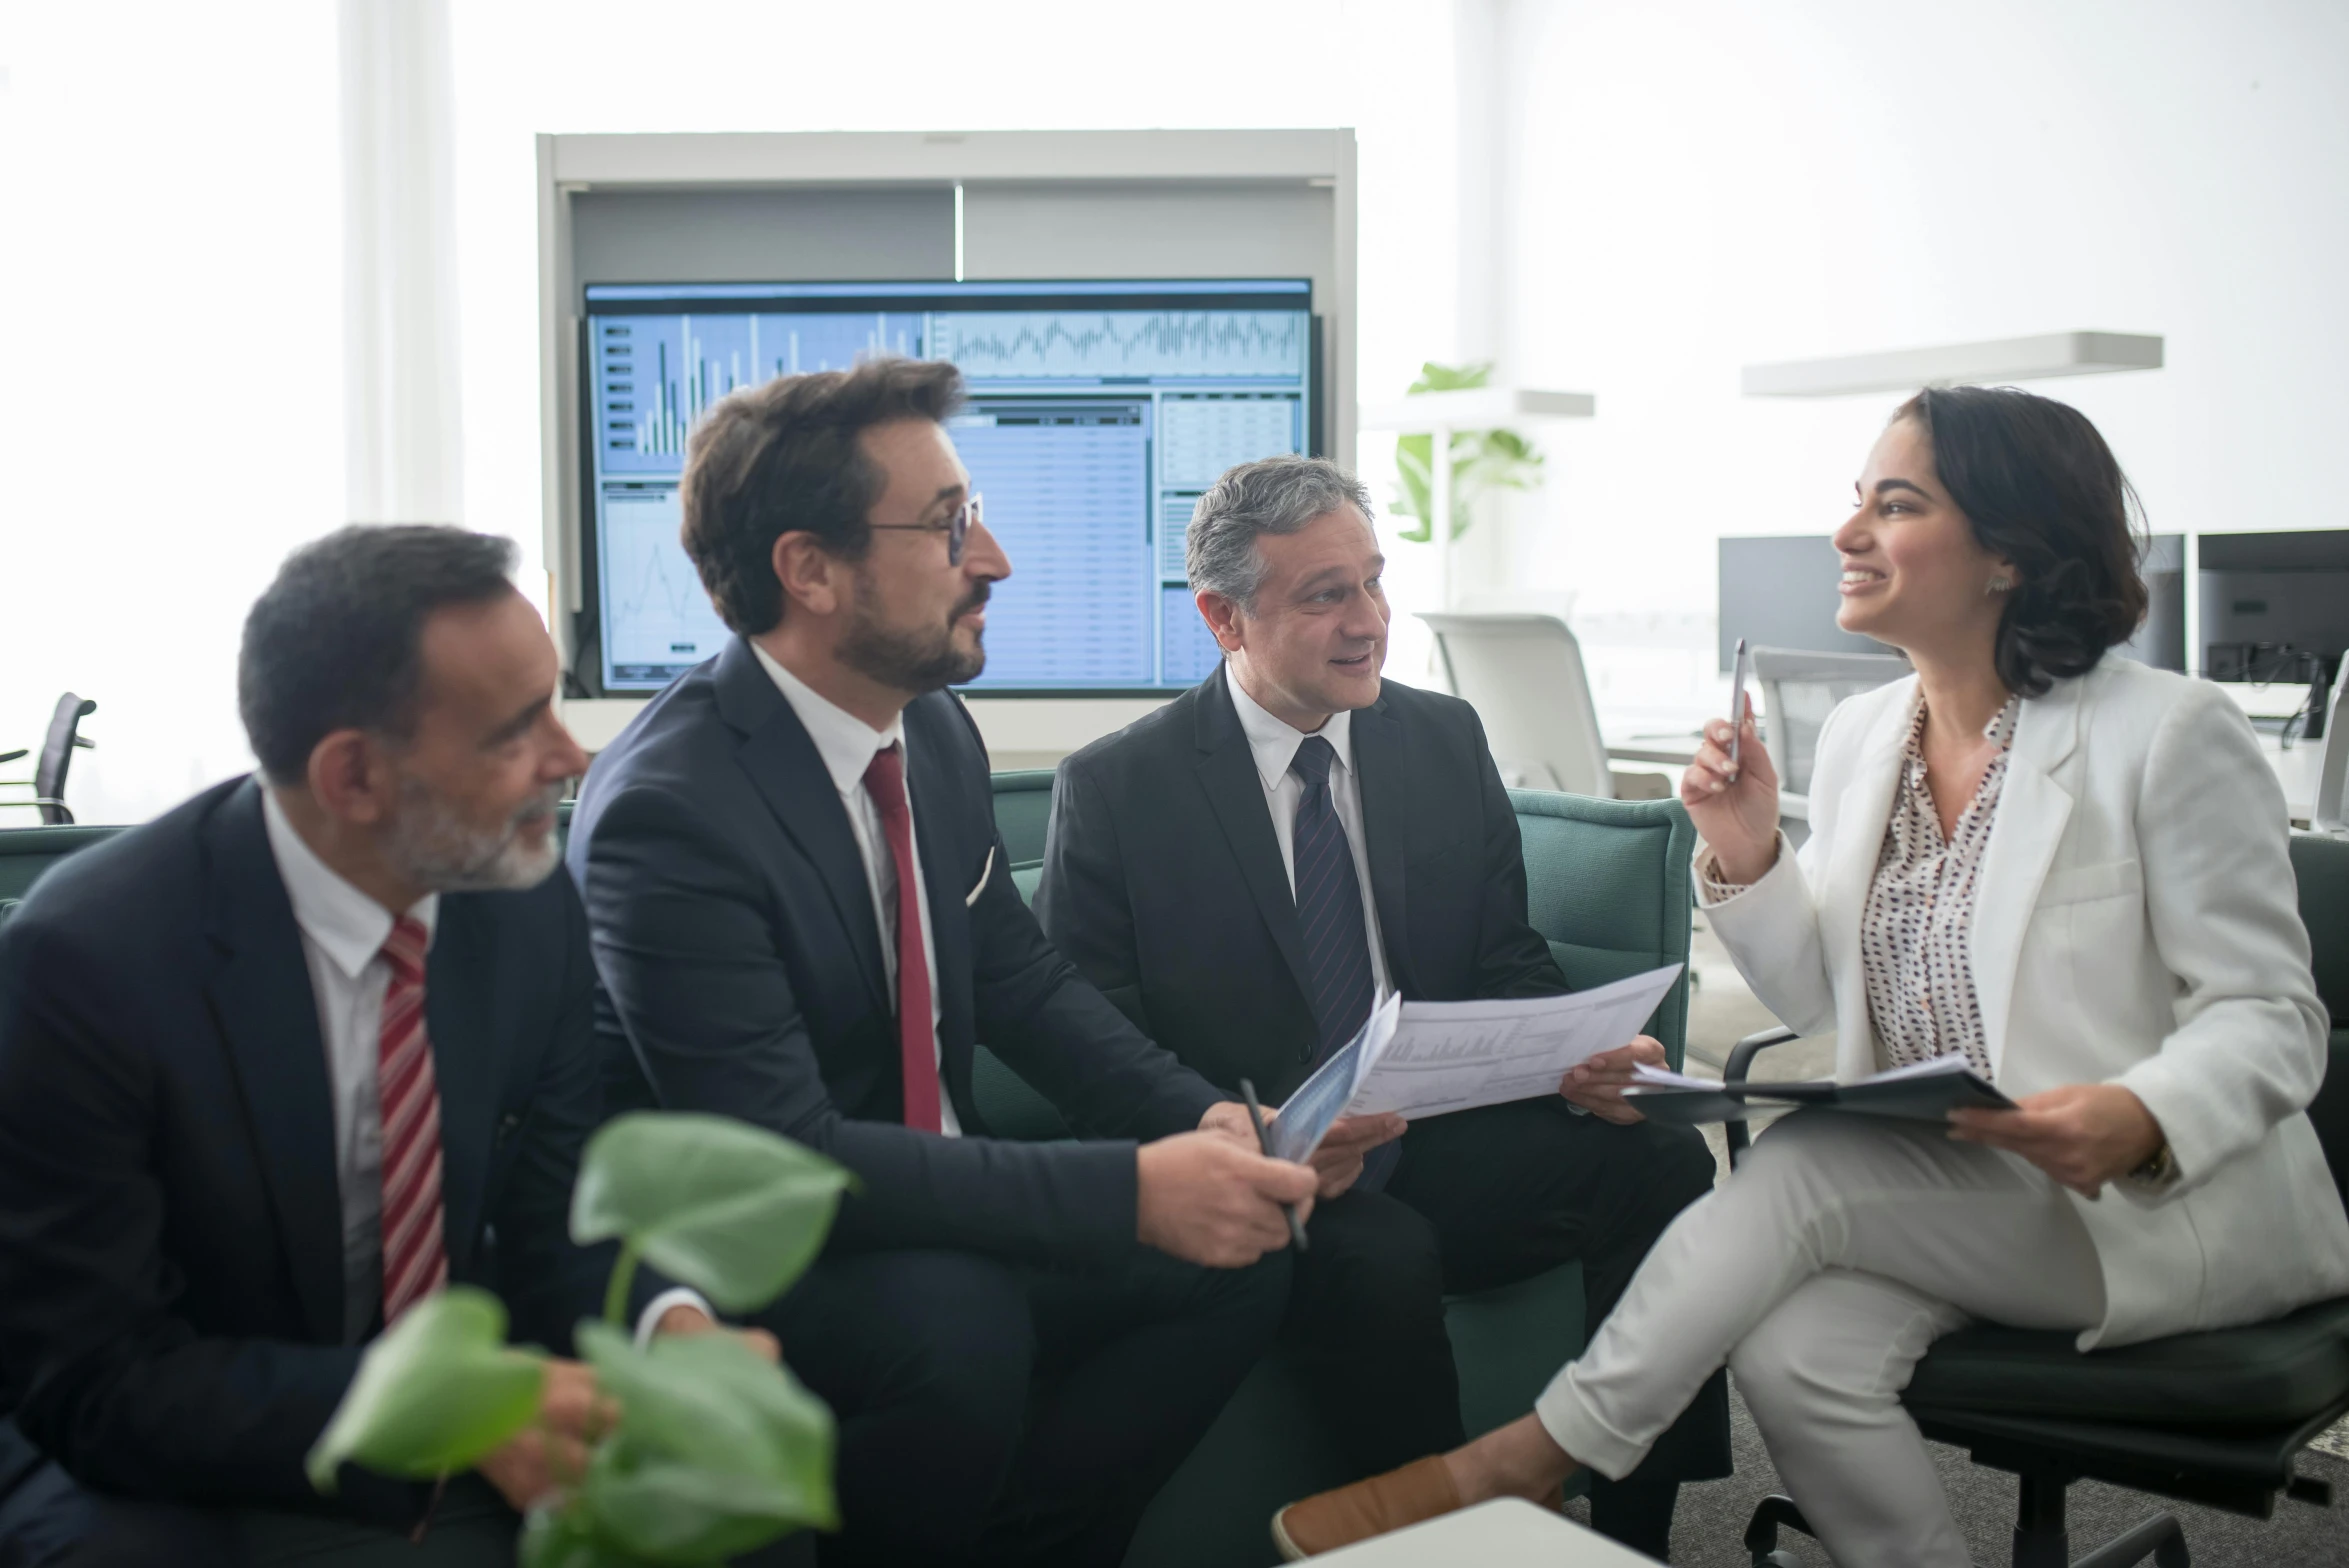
(0, 779, 604, 1521)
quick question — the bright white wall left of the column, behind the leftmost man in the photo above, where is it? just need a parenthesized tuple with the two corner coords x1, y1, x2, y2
(0, 0, 343, 826)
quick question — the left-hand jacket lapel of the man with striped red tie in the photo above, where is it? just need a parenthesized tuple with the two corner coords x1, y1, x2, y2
(204, 784, 343, 1345)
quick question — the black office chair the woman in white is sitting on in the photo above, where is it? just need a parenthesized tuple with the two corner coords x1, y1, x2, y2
(1722, 833, 2349, 1568)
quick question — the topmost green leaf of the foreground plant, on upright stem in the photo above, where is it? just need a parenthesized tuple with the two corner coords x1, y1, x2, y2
(571, 1110, 853, 1312)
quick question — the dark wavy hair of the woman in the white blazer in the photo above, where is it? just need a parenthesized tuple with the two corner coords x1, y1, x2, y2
(1893, 387, 2147, 697)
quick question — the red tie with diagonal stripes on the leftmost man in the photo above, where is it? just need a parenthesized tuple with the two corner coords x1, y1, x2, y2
(376, 915, 449, 1329)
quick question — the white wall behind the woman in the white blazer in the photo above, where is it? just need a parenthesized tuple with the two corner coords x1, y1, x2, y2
(1489, 0, 2349, 641)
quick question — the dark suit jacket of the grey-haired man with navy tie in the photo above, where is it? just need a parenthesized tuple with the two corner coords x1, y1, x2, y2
(1036, 667, 1567, 1101)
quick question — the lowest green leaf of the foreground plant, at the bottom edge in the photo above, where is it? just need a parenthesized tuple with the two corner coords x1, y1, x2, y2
(580, 1324, 839, 1528)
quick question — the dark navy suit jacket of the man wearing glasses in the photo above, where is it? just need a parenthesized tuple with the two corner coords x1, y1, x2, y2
(571, 638, 1224, 1263)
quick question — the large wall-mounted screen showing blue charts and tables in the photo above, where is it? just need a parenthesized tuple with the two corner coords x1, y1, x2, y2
(583, 279, 1315, 695)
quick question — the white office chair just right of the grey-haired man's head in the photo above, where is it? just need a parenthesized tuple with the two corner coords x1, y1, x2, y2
(1419, 613, 1654, 800)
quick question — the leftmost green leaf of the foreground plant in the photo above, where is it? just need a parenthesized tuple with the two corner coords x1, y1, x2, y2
(308, 1284, 547, 1493)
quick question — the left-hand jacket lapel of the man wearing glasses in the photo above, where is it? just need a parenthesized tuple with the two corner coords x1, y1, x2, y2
(716, 636, 895, 1009)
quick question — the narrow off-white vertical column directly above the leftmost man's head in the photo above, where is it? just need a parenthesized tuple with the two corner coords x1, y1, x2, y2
(341, 0, 465, 523)
